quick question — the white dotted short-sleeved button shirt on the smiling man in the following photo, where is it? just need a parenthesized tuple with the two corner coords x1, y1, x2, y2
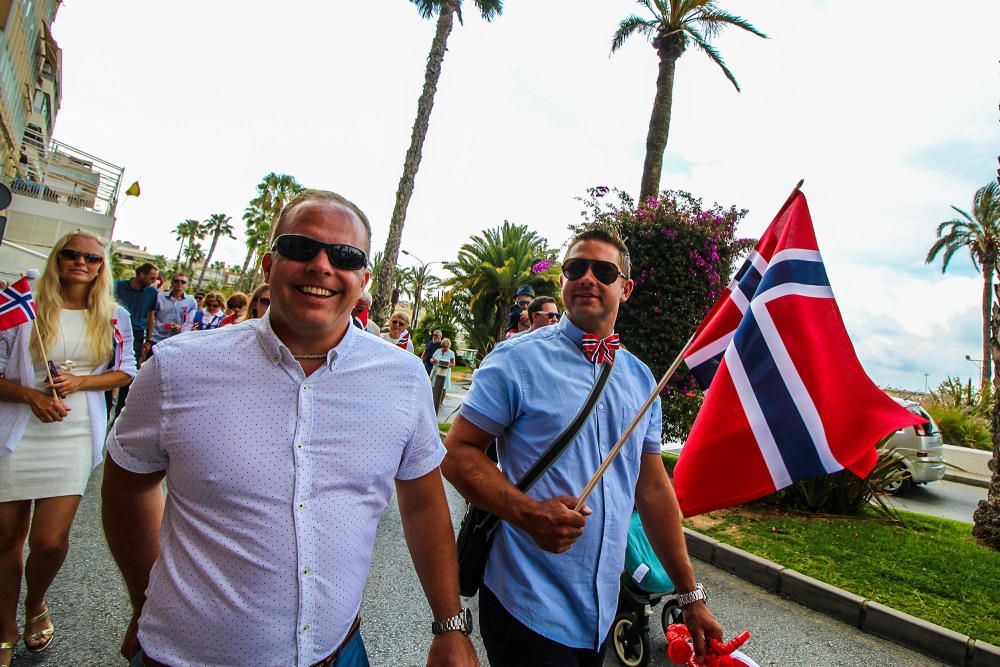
(107, 315, 444, 667)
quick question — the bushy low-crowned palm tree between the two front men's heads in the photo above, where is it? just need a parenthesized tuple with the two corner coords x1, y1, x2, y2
(443, 220, 560, 356)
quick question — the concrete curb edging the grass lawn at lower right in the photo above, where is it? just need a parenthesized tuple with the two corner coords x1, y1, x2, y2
(684, 528, 1000, 667)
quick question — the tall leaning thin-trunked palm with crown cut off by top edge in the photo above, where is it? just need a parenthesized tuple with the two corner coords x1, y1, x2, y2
(372, 0, 503, 322)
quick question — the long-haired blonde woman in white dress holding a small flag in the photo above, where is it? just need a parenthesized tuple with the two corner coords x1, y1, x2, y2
(0, 230, 136, 666)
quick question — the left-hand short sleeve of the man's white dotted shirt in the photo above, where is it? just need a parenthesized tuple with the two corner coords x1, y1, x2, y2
(106, 354, 168, 474)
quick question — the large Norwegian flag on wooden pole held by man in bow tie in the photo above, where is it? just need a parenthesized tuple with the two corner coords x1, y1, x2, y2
(674, 191, 924, 516)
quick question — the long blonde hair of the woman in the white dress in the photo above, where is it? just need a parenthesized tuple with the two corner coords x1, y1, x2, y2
(31, 229, 115, 363)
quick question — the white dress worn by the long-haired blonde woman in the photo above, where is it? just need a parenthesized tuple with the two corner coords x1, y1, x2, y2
(0, 309, 97, 502)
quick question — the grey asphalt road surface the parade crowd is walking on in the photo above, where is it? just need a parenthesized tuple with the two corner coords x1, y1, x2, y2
(7, 470, 941, 667)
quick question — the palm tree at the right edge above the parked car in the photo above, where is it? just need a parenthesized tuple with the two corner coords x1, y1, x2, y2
(926, 181, 1000, 387)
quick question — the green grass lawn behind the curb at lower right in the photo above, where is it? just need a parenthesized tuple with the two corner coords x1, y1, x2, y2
(686, 506, 1000, 646)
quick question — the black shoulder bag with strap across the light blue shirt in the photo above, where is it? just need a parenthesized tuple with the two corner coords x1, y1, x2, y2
(456, 364, 611, 597)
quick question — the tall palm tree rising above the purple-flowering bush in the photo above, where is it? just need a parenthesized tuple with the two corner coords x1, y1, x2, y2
(611, 0, 767, 203)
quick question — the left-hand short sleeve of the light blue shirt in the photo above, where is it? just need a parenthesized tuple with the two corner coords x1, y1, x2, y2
(459, 346, 522, 436)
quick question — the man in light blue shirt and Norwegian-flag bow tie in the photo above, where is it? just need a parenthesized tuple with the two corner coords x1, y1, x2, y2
(442, 228, 722, 667)
